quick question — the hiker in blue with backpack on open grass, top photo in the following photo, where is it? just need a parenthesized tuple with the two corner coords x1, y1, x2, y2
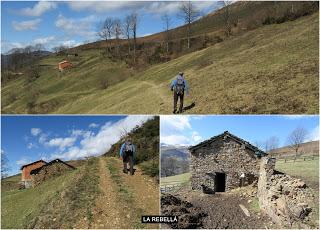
(170, 72, 189, 113)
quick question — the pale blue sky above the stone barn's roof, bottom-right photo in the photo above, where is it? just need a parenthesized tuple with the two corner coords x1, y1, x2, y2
(160, 115, 319, 146)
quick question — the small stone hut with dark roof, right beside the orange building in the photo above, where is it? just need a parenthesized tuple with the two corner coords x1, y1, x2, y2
(30, 159, 75, 186)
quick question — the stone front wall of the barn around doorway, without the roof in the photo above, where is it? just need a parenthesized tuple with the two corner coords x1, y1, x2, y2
(190, 137, 259, 190)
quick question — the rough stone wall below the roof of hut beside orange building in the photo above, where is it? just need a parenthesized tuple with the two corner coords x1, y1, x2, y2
(32, 162, 72, 186)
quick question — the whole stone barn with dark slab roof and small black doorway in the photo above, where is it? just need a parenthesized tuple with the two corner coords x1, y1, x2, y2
(189, 131, 266, 193)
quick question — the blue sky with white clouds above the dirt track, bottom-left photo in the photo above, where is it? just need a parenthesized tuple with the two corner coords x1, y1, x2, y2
(1, 115, 151, 174)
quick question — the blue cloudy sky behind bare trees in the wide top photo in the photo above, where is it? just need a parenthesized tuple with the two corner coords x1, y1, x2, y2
(1, 1, 221, 53)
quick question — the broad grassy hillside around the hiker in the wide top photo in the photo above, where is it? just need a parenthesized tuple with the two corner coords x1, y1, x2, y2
(2, 13, 319, 114)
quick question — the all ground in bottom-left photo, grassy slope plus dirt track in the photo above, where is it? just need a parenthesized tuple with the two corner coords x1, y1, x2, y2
(1, 157, 159, 229)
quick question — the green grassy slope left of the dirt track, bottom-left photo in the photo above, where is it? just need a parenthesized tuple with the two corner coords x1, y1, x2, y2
(1, 158, 99, 229)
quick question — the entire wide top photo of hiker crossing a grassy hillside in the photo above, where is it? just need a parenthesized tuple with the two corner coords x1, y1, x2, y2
(1, 1, 319, 114)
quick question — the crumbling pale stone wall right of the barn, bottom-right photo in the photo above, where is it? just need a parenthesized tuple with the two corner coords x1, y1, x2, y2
(258, 157, 314, 228)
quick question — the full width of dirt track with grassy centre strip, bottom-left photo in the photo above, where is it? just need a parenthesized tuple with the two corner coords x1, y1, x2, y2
(90, 157, 159, 229)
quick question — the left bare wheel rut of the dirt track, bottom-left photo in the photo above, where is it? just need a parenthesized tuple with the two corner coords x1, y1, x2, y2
(91, 158, 128, 229)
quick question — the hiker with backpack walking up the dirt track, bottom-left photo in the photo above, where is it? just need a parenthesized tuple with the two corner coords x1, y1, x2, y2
(120, 137, 136, 175)
